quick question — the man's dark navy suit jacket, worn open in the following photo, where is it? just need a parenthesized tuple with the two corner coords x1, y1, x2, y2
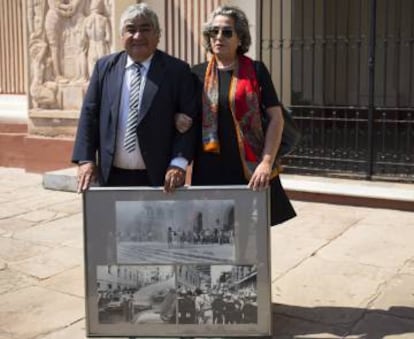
(72, 50, 197, 186)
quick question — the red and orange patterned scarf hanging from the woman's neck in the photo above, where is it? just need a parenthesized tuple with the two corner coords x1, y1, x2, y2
(202, 55, 277, 180)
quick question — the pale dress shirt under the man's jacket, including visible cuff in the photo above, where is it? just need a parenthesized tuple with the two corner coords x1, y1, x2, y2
(113, 55, 188, 170)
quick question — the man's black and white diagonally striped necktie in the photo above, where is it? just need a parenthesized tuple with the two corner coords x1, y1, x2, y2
(124, 63, 142, 153)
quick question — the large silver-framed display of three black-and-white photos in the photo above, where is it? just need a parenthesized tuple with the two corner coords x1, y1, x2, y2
(83, 186, 271, 337)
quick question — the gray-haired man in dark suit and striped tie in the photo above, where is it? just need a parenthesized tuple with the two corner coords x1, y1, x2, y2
(72, 3, 196, 192)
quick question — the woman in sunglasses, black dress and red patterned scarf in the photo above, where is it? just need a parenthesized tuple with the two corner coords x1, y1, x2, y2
(188, 6, 296, 225)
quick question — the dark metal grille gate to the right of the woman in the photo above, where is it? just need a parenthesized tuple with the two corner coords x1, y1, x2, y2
(285, 0, 414, 182)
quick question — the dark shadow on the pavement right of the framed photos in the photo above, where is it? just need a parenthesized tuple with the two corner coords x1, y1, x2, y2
(272, 304, 414, 339)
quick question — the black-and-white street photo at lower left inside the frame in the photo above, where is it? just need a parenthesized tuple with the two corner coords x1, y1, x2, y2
(96, 265, 176, 324)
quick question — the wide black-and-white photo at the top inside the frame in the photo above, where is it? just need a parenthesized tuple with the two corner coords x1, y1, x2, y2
(116, 200, 235, 264)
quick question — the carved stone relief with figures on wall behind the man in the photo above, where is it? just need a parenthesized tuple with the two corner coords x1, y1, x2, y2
(27, 0, 113, 110)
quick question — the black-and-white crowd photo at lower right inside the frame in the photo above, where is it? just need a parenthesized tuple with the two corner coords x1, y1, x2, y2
(177, 265, 257, 325)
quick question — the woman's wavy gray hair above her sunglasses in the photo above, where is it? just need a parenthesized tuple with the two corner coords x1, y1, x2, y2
(203, 6, 252, 54)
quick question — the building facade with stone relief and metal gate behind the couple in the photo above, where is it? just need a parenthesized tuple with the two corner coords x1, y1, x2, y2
(0, 0, 414, 182)
